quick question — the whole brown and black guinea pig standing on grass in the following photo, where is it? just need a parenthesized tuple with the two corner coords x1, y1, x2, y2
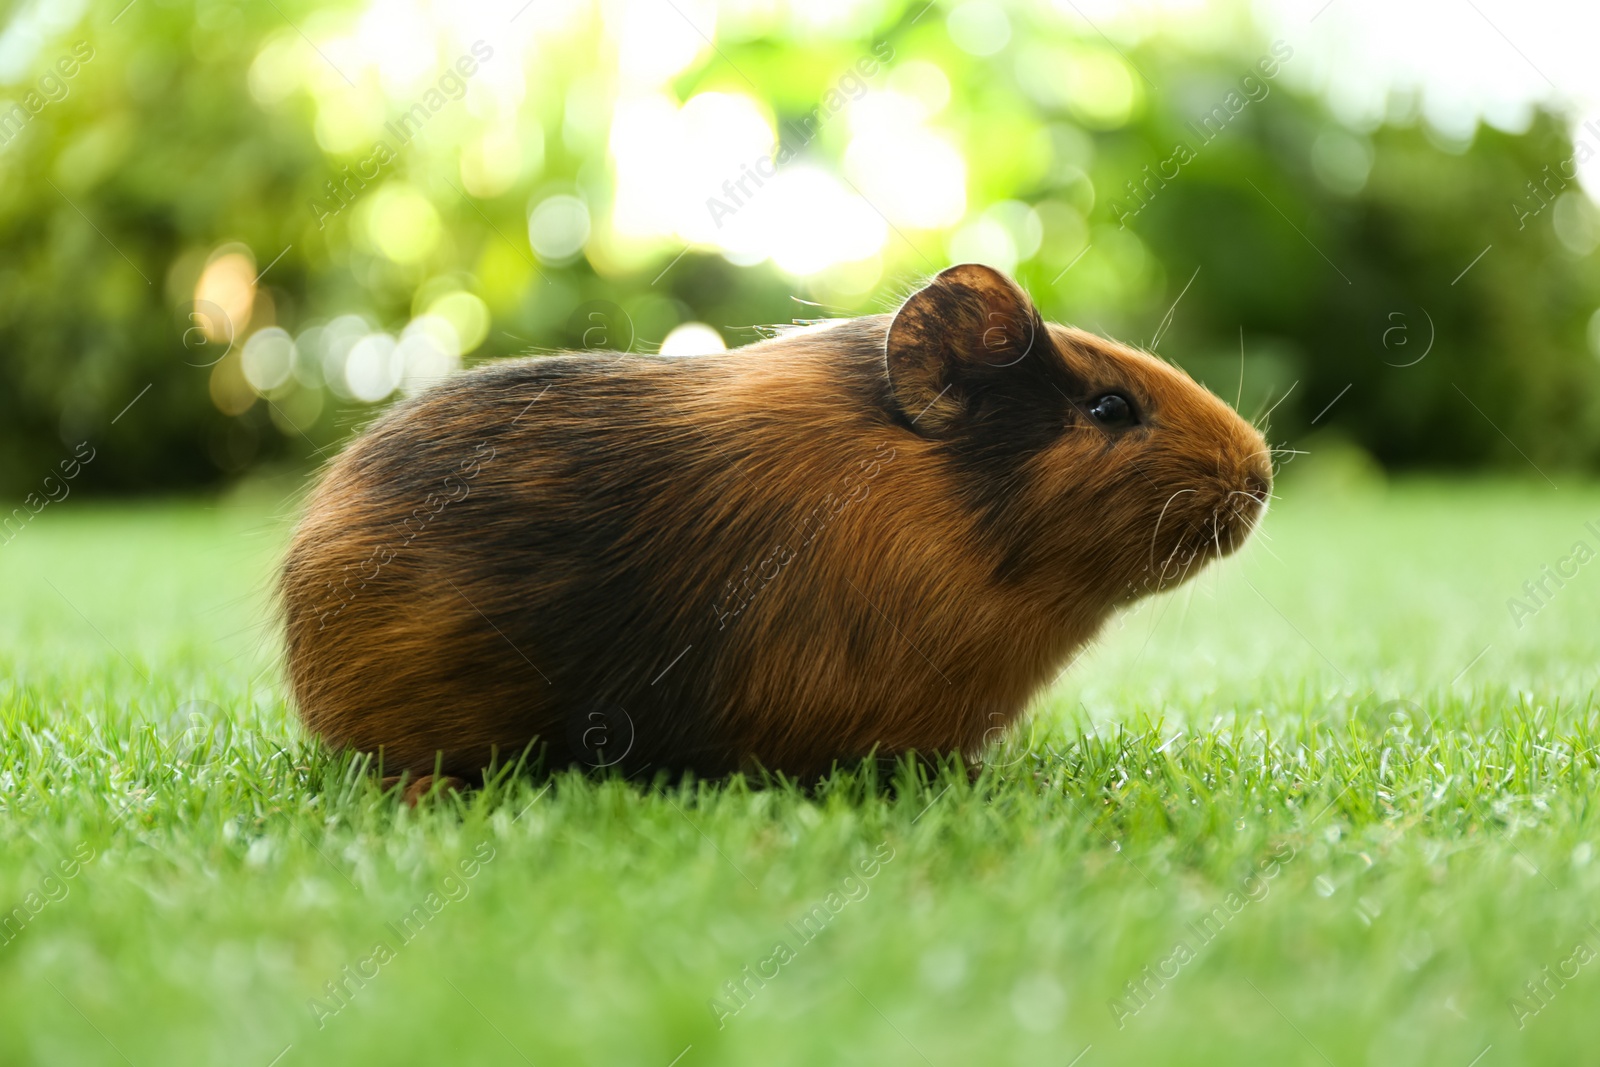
(280, 264, 1272, 774)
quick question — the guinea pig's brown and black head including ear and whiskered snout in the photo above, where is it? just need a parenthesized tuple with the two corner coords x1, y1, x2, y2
(885, 264, 1272, 608)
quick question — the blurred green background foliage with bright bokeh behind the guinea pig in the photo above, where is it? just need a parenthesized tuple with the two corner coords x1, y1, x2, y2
(0, 0, 1600, 496)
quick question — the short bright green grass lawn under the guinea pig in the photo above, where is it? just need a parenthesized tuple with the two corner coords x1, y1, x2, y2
(0, 480, 1600, 1067)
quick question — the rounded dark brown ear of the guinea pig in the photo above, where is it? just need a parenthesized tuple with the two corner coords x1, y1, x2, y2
(885, 262, 1046, 437)
